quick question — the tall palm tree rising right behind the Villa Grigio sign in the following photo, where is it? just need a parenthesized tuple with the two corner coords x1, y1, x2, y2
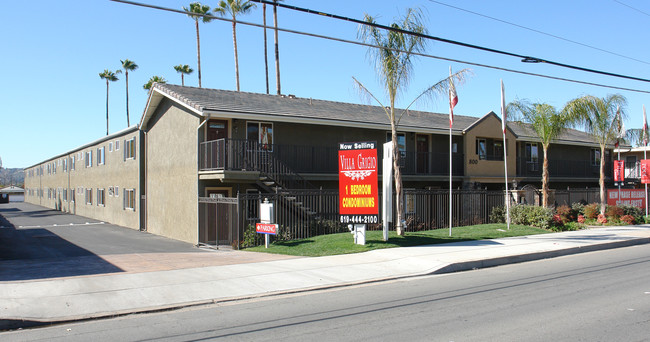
(353, 9, 468, 235)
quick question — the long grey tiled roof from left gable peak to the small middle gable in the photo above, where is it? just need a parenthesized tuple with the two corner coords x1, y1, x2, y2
(141, 83, 478, 134)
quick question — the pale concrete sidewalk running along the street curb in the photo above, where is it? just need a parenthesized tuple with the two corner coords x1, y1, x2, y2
(0, 225, 650, 329)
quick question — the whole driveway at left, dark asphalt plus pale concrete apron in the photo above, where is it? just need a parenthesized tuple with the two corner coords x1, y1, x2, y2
(0, 202, 289, 281)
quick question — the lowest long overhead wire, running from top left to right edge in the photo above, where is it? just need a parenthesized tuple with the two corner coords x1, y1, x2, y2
(111, 0, 650, 94)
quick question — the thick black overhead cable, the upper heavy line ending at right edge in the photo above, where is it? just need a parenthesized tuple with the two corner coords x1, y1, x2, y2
(250, 0, 650, 83)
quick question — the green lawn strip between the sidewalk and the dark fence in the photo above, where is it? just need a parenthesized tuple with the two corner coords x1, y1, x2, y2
(246, 223, 551, 256)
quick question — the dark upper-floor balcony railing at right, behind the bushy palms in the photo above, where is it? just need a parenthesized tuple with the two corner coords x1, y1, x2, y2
(517, 157, 612, 178)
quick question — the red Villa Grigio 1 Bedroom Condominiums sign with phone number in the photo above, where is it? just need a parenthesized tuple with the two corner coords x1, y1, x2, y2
(338, 142, 379, 224)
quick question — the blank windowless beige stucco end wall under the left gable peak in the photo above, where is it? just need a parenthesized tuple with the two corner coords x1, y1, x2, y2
(145, 100, 200, 244)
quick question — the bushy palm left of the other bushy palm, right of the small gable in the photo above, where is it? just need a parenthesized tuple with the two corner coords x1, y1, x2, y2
(508, 101, 571, 207)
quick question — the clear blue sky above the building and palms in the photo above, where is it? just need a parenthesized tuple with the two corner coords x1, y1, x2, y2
(0, 0, 650, 168)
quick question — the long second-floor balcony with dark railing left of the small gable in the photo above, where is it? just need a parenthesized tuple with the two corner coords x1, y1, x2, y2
(199, 139, 464, 176)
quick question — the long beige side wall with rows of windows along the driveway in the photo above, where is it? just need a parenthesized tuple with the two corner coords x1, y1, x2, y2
(25, 129, 140, 229)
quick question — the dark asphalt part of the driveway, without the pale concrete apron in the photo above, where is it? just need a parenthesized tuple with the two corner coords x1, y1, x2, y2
(0, 202, 205, 281)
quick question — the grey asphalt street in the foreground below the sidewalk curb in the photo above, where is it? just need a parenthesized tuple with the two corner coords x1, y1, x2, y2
(5, 246, 650, 341)
